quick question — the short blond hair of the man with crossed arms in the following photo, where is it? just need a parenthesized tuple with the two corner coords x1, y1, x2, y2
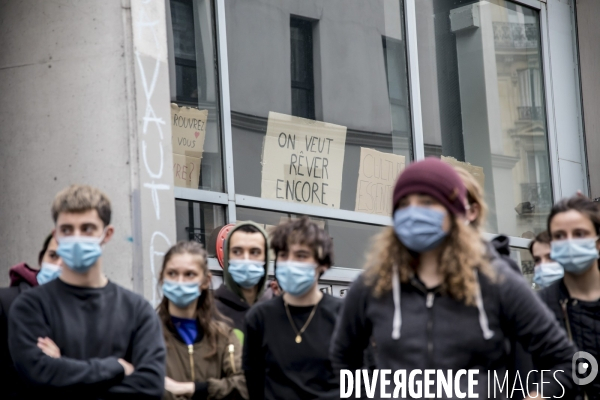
(52, 185, 111, 226)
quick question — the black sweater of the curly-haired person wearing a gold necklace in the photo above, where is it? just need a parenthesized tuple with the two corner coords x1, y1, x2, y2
(242, 294, 342, 400)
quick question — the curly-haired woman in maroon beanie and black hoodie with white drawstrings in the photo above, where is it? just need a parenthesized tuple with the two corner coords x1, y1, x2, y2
(330, 158, 575, 398)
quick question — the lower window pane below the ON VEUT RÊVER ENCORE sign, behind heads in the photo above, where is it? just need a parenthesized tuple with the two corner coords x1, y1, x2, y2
(236, 207, 382, 269)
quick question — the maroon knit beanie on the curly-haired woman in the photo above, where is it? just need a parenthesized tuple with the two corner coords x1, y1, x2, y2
(392, 157, 467, 215)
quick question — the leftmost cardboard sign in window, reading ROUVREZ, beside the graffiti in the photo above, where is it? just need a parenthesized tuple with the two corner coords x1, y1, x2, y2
(171, 103, 208, 189)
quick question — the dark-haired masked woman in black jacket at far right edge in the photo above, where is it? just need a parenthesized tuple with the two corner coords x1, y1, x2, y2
(540, 195, 600, 400)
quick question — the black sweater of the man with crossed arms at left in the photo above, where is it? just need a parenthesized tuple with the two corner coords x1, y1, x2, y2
(9, 279, 165, 399)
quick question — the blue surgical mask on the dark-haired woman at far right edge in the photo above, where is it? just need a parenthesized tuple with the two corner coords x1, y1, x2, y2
(550, 237, 598, 275)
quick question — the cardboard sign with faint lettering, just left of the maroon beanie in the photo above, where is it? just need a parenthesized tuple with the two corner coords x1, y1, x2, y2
(354, 147, 406, 216)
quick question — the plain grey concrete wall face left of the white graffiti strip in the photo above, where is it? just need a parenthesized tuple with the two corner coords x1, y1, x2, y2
(0, 0, 132, 287)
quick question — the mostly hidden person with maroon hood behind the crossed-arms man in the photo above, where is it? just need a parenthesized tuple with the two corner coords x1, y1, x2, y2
(0, 234, 62, 399)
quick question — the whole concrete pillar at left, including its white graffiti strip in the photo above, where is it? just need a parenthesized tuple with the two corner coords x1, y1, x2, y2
(0, 0, 175, 299)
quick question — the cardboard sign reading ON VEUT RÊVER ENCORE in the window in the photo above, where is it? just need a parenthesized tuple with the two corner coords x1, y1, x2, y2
(261, 112, 346, 208)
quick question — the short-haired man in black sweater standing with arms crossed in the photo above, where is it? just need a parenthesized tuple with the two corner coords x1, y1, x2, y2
(8, 185, 165, 400)
